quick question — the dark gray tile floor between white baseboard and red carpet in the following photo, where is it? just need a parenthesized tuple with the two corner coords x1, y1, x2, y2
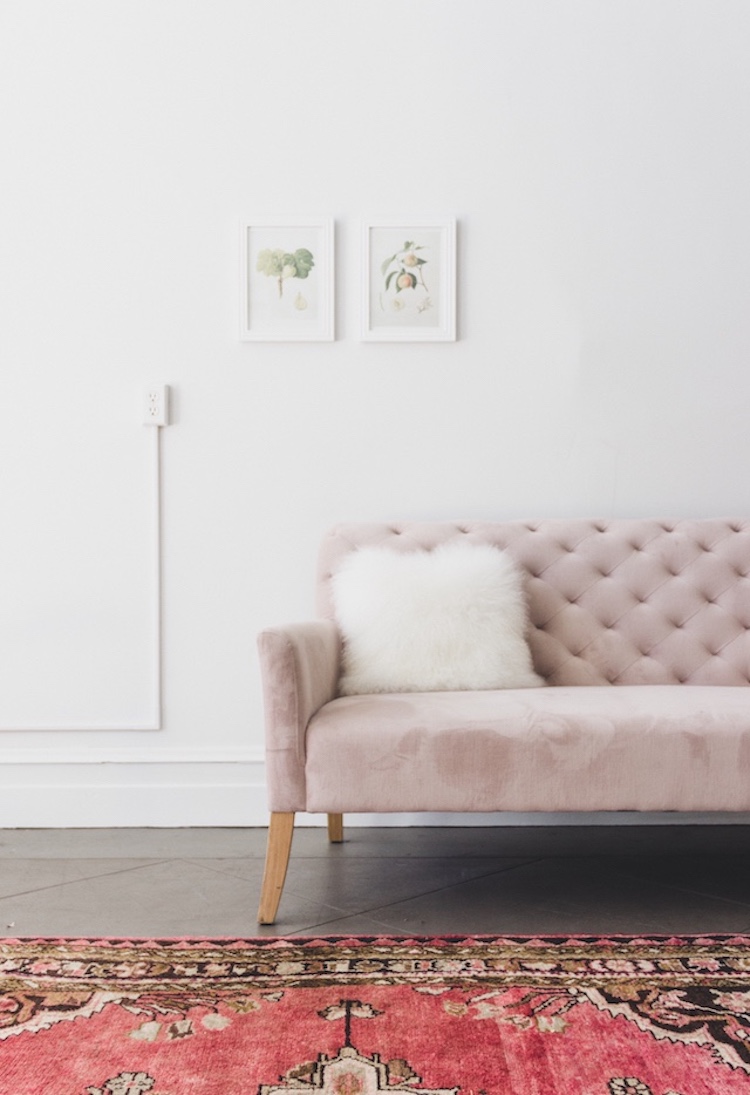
(0, 825, 750, 937)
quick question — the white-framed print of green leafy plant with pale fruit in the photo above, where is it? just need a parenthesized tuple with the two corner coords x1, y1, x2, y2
(240, 217, 334, 342)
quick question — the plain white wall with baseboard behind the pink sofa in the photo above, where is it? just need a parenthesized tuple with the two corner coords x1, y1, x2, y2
(0, 0, 750, 826)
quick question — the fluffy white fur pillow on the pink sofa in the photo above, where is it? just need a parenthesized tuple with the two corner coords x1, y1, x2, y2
(333, 541, 544, 695)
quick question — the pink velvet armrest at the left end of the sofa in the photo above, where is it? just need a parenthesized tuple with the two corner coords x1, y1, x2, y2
(258, 620, 342, 811)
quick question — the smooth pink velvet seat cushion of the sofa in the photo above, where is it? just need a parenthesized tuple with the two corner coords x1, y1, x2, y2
(305, 684, 750, 812)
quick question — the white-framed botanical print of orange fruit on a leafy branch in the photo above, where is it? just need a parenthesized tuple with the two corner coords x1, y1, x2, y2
(361, 217, 455, 342)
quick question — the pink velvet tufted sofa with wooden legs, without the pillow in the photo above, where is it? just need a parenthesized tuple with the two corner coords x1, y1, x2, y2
(258, 519, 750, 923)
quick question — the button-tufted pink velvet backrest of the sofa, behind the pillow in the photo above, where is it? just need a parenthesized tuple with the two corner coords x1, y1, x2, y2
(318, 519, 750, 684)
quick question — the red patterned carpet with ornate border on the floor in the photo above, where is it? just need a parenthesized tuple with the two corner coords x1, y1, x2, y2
(0, 936, 750, 1095)
